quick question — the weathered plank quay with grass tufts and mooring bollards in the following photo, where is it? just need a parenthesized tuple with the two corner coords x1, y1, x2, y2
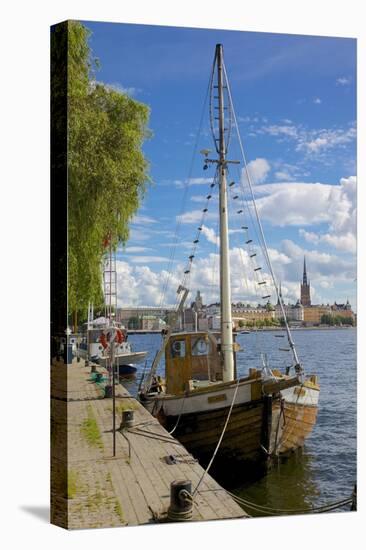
(51, 360, 248, 529)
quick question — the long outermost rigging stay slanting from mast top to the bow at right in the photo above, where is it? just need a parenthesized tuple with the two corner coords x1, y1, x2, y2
(222, 57, 303, 373)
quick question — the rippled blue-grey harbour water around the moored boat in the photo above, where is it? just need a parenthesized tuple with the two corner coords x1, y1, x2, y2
(123, 329, 357, 515)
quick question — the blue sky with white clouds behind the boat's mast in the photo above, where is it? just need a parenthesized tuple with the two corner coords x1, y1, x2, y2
(85, 22, 356, 308)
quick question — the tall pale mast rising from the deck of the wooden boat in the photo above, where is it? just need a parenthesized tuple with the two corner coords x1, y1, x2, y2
(216, 44, 234, 382)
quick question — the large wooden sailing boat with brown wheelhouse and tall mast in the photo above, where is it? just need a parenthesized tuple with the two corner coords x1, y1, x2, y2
(139, 44, 319, 484)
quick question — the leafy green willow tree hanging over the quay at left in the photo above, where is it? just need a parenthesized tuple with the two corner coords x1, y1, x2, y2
(68, 22, 149, 326)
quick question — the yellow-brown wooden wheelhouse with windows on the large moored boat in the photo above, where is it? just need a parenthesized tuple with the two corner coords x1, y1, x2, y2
(165, 332, 236, 395)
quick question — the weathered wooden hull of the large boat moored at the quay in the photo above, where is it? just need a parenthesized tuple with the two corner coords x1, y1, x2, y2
(142, 384, 319, 479)
